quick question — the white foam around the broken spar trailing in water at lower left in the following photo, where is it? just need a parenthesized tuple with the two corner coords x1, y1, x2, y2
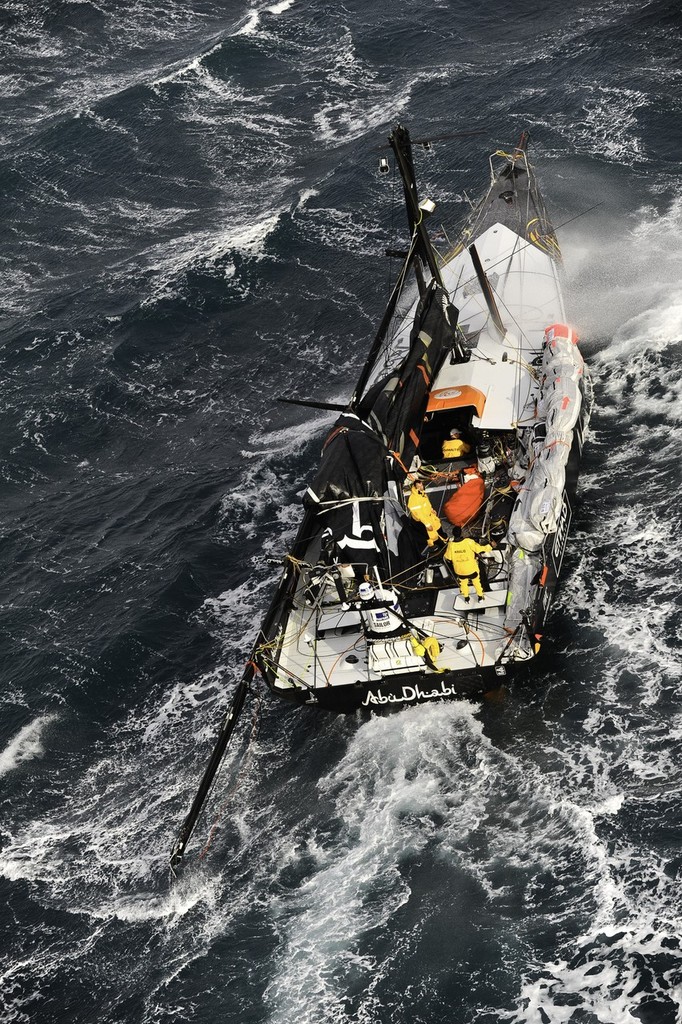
(0, 659, 307, 1024)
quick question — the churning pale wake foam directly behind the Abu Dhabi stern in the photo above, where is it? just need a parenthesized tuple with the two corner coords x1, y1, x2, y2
(260, 705, 622, 1024)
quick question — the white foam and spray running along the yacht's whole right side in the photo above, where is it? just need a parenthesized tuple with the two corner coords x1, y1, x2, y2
(498, 188, 682, 1024)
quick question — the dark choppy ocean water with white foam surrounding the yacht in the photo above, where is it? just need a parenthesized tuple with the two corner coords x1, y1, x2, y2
(0, 0, 682, 1024)
